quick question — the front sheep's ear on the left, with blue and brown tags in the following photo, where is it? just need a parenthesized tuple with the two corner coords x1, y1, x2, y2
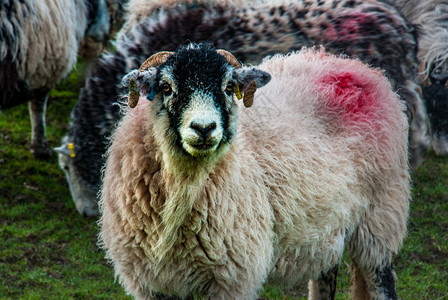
(121, 68, 157, 108)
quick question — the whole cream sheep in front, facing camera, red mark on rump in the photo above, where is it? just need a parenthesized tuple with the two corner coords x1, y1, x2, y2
(99, 44, 410, 299)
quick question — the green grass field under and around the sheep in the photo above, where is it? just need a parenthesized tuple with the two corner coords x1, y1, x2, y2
(0, 62, 448, 299)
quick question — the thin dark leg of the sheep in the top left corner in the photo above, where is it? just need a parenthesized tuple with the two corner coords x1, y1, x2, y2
(28, 89, 52, 158)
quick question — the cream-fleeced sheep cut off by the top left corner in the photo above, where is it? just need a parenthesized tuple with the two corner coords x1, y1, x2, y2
(0, 0, 117, 157)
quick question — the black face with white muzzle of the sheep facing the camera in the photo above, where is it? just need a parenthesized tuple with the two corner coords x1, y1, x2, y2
(157, 61, 231, 157)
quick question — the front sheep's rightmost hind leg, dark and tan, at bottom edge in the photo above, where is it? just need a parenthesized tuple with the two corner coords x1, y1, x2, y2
(351, 264, 398, 300)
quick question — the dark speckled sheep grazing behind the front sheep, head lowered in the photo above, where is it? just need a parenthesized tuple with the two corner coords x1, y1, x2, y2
(57, 0, 430, 216)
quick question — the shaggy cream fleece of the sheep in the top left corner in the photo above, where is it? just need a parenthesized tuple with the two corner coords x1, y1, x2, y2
(0, 0, 87, 89)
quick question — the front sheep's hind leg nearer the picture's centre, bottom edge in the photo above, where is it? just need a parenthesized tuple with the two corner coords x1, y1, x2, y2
(308, 266, 339, 300)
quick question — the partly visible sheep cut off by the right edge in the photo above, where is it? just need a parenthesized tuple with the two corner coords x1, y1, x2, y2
(392, 0, 448, 155)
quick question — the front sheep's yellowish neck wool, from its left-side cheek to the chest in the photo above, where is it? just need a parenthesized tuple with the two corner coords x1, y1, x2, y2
(146, 102, 237, 261)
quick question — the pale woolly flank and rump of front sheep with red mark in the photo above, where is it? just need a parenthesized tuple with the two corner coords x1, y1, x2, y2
(245, 51, 410, 286)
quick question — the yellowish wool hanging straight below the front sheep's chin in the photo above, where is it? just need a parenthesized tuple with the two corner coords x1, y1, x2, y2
(156, 136, 236, 259)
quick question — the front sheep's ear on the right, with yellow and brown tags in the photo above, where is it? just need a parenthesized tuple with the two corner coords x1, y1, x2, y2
(235, 67, 271, 107)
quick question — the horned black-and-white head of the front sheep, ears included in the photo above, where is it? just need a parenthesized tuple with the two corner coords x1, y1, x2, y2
(122, 44, 270, 157)
